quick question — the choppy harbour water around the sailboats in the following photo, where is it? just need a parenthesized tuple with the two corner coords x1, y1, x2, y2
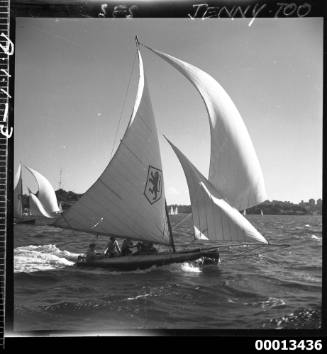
(14, 215, 322, 333)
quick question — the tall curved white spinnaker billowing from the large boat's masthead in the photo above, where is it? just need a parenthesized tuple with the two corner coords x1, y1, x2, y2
(143, 44, 267, 210)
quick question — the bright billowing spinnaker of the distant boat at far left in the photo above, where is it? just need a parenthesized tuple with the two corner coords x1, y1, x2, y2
(25, 166, 60, 214)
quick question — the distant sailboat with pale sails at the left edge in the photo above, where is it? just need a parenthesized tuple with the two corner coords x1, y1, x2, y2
(14, 164, 60, 224)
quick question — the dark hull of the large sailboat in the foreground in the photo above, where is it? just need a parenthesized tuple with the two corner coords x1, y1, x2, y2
(76, 249, 219, 271)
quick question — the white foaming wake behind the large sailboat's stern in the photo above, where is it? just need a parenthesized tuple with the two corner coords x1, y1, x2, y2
(14, 244, 79, 273)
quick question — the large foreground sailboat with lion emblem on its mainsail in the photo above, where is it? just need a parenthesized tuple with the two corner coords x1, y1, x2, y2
(54, 38, 267, 270)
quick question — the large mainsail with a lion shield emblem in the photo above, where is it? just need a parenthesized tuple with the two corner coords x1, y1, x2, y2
(55, 50, 170, 244)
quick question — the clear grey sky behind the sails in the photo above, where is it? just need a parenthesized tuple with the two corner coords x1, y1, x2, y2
(14, 18, 323, 204)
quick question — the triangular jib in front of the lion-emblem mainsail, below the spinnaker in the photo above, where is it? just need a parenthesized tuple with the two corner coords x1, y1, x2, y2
(167, 139, 267, 243)
